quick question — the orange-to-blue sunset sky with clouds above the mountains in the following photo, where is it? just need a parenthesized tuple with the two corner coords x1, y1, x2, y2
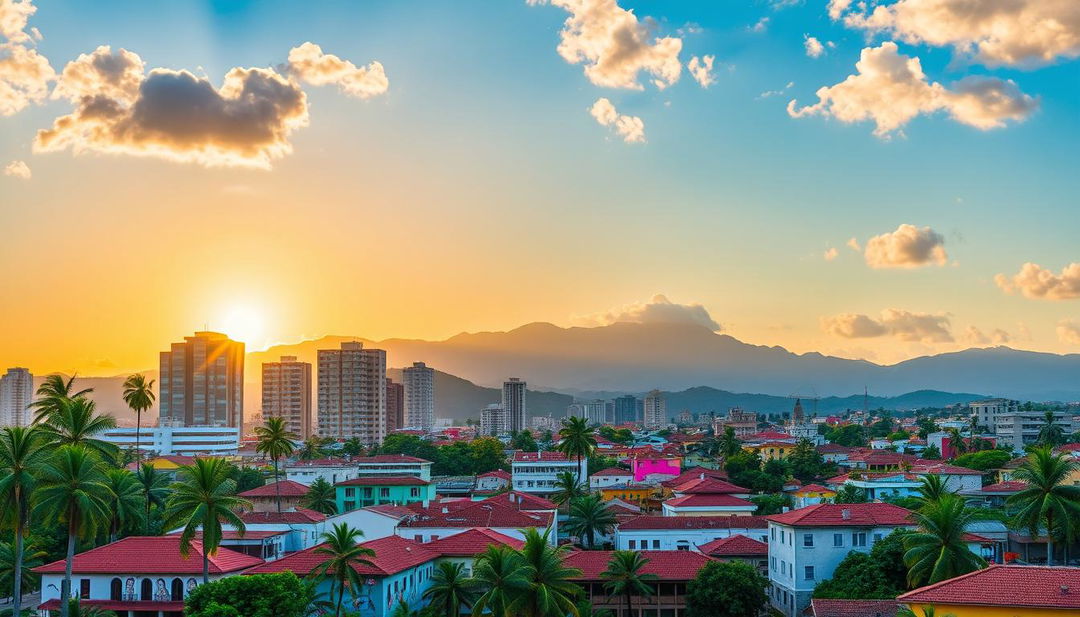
(0, 0, 1080, 375)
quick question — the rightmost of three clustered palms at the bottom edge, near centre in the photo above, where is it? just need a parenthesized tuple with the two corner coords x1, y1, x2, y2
(507, 527, 581, 617)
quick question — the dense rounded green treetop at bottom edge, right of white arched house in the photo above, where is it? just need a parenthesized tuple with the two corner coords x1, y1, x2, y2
(184, 572, 308, 617)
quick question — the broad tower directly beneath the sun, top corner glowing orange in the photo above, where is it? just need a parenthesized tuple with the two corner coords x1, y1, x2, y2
(158, 332, 244, 427)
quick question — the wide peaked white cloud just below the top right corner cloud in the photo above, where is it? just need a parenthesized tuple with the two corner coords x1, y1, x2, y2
(787, 41, 1038, 137)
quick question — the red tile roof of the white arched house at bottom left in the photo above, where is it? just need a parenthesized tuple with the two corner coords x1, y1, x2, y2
(33, 536, 262, 574)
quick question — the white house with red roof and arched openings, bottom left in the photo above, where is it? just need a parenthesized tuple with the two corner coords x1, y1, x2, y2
(33, 535, 264, 617)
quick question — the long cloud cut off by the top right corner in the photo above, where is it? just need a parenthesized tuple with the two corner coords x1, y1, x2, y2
(829, 0, 1080, 67)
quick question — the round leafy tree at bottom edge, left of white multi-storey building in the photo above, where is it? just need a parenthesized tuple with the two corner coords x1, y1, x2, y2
(686, 561, 769, 617)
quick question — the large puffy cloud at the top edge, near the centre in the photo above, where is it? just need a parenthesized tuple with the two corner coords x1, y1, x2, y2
(527, 0, 683, 90)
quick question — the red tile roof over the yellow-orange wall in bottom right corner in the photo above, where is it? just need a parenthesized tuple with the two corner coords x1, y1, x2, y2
(896, 565, 1080, 613)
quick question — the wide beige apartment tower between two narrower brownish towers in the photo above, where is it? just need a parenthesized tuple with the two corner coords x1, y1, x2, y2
(319, 341, 387, 446)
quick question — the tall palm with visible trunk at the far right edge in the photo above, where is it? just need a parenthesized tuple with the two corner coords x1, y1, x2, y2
(1007, 446, 1080, 565)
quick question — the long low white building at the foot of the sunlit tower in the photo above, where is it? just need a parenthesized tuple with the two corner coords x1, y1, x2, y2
(102, 426, 240, 456)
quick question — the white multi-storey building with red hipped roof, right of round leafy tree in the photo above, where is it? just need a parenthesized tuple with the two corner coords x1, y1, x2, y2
(767, 504, 915, 617)
